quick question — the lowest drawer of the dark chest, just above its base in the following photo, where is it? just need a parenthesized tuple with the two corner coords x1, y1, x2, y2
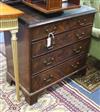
(32, 55, 86, 92)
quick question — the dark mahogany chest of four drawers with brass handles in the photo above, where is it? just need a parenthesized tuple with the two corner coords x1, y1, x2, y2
(5, 3, 95, 104)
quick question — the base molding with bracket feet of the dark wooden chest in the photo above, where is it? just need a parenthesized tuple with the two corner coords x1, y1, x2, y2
(6, 66, 86, 105)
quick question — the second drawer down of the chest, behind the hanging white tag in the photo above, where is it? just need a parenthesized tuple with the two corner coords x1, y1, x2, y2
(32, 26, 92, 57)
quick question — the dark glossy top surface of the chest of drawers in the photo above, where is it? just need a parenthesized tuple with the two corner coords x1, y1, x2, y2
(10, 3, 96, 27)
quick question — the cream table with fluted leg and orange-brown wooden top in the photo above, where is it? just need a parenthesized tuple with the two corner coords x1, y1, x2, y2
(0, 2, 23, 101)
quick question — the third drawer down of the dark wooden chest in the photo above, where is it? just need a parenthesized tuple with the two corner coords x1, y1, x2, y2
(32, 39, 90, 74)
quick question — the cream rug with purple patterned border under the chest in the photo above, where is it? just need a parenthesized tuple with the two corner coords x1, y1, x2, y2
(0, 54, 100, 112)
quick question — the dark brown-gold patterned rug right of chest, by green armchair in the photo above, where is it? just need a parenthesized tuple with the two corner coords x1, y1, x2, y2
(70, 56, 100, 92)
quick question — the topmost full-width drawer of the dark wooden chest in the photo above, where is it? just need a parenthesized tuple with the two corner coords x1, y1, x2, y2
(30, 14, 94, 41)
